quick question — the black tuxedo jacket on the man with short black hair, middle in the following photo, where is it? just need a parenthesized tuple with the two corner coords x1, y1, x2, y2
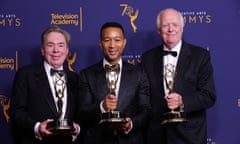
(78, 61, 150, 144)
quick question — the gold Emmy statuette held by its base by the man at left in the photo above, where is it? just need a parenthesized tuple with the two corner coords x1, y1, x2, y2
(47, 71, 74, 134)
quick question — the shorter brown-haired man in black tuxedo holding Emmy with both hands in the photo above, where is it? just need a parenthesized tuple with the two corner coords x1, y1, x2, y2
(10, 26, 80, 144)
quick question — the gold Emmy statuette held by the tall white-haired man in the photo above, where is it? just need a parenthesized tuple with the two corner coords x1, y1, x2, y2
(161, 64, 187, 124)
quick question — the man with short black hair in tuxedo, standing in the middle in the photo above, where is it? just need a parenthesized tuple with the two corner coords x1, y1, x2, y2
(78, 22, 150, 144)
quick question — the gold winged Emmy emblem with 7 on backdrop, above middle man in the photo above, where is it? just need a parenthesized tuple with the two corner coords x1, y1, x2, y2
(120, 4, 139, 32)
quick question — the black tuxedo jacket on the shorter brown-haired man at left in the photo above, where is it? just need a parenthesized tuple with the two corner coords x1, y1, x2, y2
(10, 63, 77, 144)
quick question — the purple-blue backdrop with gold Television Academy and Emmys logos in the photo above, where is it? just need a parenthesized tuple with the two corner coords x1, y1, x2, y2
(0, 0, 240, 144)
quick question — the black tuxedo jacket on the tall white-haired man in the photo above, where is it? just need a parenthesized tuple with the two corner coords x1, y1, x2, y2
(142, 41, 216, 144)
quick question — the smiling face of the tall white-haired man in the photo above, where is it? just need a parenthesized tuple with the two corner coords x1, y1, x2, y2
(158, 9, 183, 48)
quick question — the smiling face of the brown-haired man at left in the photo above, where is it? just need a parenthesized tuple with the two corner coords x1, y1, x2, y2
(41, 32, 69, 69)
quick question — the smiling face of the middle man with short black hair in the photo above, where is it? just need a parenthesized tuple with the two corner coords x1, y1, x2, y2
(99, 27, 126, 64)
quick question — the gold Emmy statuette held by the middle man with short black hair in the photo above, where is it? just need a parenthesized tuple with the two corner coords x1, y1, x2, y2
(99, 65, 127, 124)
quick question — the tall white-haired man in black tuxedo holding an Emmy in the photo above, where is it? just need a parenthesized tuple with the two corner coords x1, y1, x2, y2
(142, 8, 216, 144)
